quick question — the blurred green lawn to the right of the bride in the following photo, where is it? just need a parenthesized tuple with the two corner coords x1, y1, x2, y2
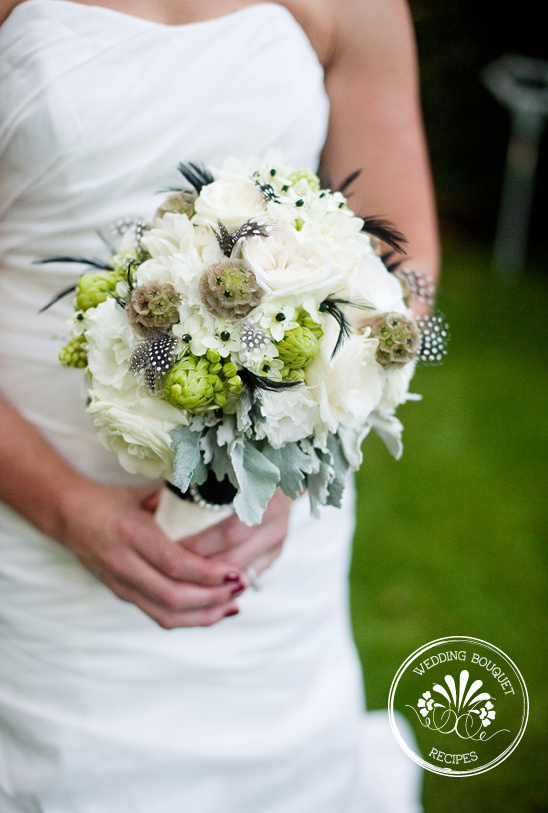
(352, 241, 548, 813)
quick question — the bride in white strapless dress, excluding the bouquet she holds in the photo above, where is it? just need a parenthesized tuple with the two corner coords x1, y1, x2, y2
(0, 0, 437, 813)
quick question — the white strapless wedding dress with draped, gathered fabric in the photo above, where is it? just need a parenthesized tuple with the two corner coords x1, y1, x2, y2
(0, 0, 419, 813)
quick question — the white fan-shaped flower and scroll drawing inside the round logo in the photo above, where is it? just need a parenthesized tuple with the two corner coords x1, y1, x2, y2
(409, 669, 507, 740)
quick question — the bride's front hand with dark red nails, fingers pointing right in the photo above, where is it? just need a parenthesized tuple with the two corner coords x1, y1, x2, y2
(59, 481, 242, 629)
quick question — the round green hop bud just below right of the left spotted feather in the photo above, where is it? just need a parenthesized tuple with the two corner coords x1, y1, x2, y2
(164, 354, 218, 413)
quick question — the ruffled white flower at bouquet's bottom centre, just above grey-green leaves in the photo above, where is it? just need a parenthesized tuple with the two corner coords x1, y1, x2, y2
(255, 387, 319, 449)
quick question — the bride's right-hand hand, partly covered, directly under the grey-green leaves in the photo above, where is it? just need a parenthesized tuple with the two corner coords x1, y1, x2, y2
(179, 489, 292, 586)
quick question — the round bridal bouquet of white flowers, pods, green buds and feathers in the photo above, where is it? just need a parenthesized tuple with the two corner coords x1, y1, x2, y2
(52, 161, 444, 535)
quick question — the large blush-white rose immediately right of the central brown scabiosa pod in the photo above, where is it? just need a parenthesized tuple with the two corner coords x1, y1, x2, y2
(242, 234, 340, 302)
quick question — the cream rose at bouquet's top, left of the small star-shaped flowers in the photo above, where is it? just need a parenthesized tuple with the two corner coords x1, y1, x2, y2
(193, 176, 266, 231)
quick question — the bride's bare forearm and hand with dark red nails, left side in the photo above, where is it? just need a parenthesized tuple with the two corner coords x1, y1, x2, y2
(0, 398, 247, 629)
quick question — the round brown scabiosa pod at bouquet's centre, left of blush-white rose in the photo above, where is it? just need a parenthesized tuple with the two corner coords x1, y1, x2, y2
(200, 258, 263, 319)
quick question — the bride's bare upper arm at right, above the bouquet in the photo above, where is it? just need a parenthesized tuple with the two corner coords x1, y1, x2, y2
(322, 0, 439, 311)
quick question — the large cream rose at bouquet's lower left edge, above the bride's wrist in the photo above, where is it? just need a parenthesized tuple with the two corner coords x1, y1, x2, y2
(88, 382, 186, 477)
